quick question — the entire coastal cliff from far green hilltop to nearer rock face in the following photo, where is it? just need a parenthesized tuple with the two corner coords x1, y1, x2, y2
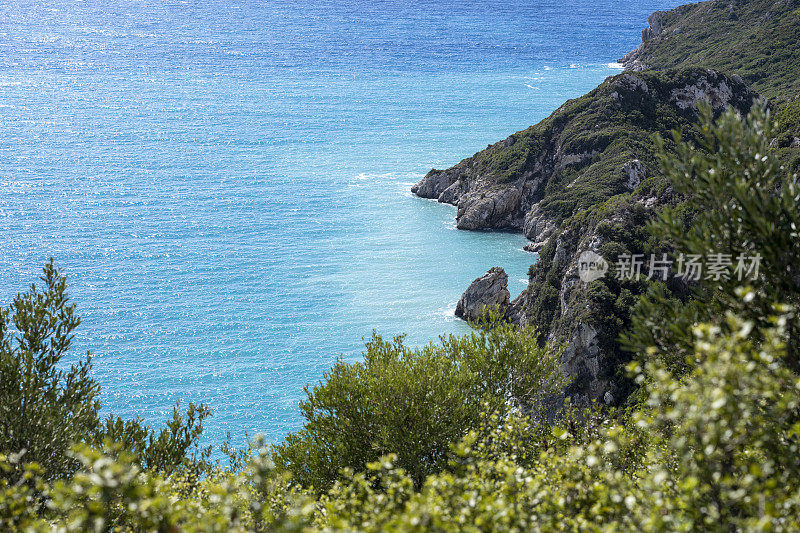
(412, 1, 800, 403)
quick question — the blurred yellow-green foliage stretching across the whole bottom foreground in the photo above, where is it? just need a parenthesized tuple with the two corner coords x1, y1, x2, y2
(0, 314, 800, 533)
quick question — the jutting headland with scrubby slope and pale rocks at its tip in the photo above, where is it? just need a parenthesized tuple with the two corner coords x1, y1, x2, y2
(412, 69, 753, 243)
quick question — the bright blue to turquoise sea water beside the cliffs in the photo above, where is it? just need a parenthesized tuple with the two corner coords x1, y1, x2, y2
(0, 0, 679, 443)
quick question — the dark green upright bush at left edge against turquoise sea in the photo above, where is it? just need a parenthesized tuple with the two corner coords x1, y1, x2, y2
(0, 260, 210, 481)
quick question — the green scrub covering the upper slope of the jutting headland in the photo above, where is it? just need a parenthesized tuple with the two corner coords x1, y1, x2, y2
(444, 67, 756, 224)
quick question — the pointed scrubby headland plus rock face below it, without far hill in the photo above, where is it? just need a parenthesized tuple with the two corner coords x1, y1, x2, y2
(413, 67, 756, 401)
